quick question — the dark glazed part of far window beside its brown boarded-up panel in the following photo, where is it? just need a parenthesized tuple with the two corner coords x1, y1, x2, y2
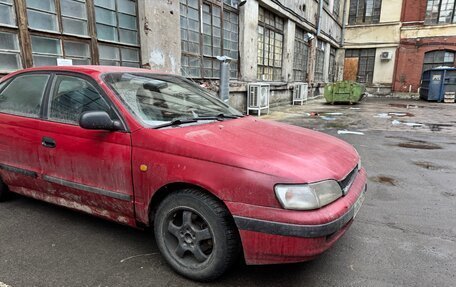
(345, 49, 376, 84)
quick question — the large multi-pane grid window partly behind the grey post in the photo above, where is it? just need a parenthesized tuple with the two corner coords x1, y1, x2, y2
(180, 0, 239, 79)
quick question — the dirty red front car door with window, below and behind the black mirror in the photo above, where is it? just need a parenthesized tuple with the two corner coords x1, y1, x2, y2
(40, 73, 134, 224)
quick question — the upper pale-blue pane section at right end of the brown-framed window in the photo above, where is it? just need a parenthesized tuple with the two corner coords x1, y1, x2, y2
(95, 0, 138, 45)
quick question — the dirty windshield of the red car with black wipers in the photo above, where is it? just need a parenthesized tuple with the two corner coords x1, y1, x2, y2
(104, 73, 242, 127)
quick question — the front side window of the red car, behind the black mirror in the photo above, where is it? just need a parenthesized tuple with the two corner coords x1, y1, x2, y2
(49, 76, 115, 124)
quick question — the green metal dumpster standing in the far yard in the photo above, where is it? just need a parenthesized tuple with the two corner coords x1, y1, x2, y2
(325, 81, 366, 104)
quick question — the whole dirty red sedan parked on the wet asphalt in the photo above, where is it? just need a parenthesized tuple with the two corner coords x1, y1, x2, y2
(0, 66, 366, 281)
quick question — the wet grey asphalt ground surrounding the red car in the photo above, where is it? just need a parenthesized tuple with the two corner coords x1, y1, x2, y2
(0, 98, 456, 287)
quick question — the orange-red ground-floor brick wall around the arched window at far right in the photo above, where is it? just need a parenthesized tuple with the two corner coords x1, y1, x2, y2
(393, 36, 456, 92)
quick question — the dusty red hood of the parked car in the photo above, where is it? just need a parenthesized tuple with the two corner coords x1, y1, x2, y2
(154, 117, 359, 183)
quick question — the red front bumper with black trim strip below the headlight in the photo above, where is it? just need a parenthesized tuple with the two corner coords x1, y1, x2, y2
(227, 170, 367, 264)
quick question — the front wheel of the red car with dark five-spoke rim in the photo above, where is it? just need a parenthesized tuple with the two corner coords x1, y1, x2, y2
(154, 189, 240, 282)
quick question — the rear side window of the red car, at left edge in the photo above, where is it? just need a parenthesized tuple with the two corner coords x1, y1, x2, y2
(0, 74, 49, 118)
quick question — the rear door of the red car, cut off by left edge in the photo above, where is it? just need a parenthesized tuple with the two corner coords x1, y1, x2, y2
(0, 72, 50, 195)
